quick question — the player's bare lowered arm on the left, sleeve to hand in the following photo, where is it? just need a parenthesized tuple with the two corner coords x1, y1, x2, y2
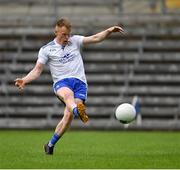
(15, 61, 44, 90)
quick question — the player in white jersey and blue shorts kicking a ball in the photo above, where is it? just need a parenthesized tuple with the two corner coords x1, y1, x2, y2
(15, 19, 124, 155)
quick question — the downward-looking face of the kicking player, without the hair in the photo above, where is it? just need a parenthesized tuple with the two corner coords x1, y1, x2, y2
(55, 26, 71, 45)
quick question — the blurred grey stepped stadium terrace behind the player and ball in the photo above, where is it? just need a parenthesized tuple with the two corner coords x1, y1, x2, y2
(0, 0, 180, 130)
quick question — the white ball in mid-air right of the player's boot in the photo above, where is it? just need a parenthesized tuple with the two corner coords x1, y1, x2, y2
(115, 103, 136, 124)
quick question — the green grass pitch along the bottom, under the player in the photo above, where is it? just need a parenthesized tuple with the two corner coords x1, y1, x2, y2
(0, 130, 180, 169)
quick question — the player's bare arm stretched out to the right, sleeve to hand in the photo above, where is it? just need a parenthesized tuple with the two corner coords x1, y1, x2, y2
(83, 26, 124, 45)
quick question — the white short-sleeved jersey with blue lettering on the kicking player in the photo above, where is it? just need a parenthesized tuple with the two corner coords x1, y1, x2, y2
(38, 35, 87, 84)
